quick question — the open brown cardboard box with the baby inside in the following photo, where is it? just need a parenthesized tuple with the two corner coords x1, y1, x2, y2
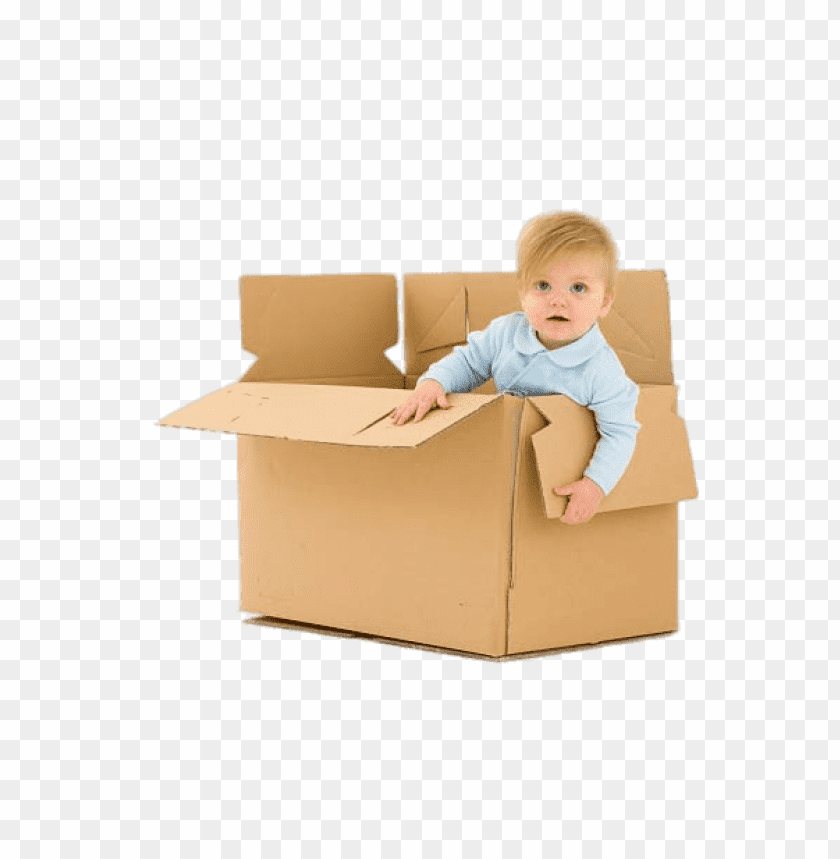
(159, 271, 697, 657)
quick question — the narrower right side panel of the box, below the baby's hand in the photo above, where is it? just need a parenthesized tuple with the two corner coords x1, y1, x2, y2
(508, 405, 677, 653)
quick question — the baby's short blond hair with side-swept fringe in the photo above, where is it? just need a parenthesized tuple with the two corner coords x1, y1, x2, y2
(516, 212, 618, 297)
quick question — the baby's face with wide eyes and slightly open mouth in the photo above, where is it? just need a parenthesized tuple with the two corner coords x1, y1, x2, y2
(521, 252, 612, 349)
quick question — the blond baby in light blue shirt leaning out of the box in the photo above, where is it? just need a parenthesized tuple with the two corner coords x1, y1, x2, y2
(391, 212, 640, 524)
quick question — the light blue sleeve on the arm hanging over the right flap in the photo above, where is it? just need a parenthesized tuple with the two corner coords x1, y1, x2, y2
(583, 358, 641, 495)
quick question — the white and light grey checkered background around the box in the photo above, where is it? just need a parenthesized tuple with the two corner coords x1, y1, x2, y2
(0, 0, 840, 859)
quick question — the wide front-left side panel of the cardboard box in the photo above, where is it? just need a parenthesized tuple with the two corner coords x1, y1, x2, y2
(239, 399, 511, 655)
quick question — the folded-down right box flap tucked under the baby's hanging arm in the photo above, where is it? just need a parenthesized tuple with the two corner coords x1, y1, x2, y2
(528, 385, 697, 519)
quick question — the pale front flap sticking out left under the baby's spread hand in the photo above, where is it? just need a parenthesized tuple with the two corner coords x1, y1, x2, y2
(158, 382, 498, 448)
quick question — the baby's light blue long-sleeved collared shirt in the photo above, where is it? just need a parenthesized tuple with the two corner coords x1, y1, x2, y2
(417, 311, 641, 495)
